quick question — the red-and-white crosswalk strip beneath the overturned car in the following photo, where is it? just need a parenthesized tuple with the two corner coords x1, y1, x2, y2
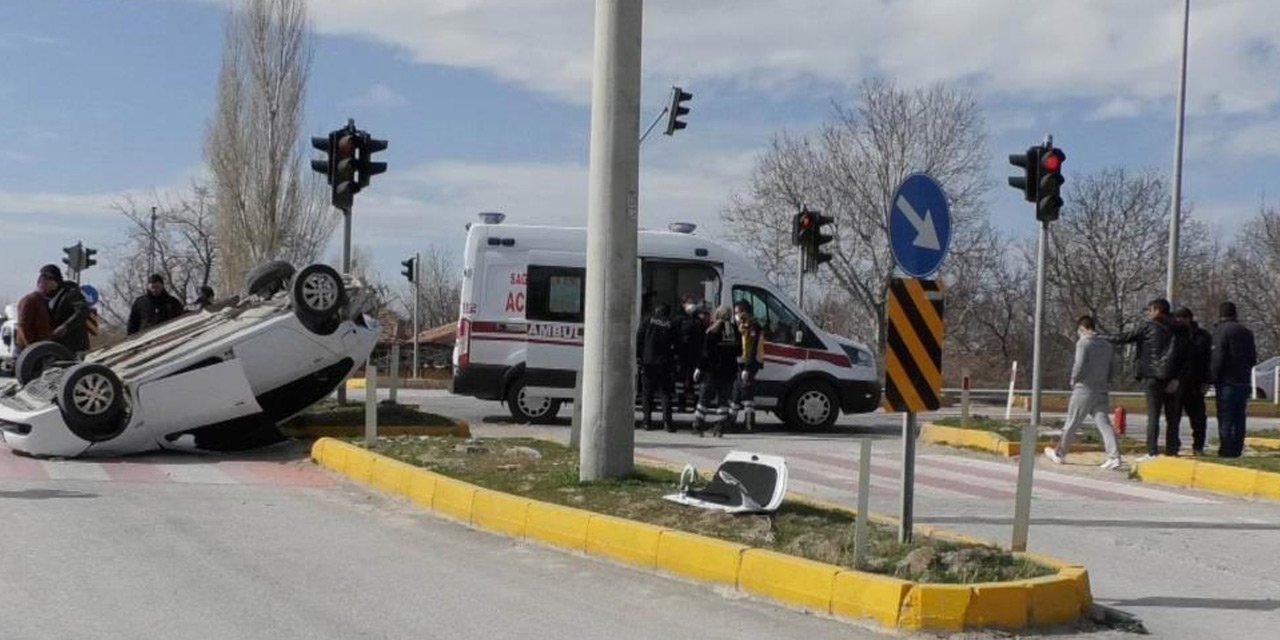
(0, 445, 334, 486)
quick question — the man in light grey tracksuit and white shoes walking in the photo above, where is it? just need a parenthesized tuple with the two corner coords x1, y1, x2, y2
(1044, 316, 1120, 468)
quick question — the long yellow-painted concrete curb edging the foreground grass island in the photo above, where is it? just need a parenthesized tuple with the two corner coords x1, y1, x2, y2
(311, 438, 1092, 631)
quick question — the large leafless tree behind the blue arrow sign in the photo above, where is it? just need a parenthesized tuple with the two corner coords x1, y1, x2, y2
(722, 81, 989, 353)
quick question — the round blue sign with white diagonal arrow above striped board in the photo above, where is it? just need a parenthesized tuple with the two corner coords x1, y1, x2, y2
(888, 173, 951, 278)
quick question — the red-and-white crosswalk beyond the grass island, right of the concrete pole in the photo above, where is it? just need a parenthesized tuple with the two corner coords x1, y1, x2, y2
(637, 443, 1220, 504)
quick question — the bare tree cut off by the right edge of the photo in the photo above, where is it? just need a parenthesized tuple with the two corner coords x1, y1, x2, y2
(1225, 205, 1280, 360)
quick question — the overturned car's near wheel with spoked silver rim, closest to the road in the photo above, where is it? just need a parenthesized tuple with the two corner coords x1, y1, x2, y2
(58, 362, 125, 442)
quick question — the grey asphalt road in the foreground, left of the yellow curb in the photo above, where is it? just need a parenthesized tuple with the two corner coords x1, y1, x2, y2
(0, 444, 883, 640)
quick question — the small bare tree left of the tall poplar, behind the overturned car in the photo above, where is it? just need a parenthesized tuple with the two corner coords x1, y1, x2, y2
(101, 183, 219, 325)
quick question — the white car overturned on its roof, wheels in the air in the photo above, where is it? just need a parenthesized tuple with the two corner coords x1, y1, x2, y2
(0, 262, 378, 457)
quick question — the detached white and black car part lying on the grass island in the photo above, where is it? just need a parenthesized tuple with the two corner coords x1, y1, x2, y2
(663, 451, 787, 513)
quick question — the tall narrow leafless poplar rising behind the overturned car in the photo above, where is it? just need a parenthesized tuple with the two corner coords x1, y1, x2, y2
(205, 0, 337, 291)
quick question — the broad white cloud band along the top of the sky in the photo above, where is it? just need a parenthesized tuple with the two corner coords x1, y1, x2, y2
(302, 0, 1280, 119)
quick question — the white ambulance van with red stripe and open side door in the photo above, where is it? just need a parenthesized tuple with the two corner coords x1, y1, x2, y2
(452, 212, 881, 429)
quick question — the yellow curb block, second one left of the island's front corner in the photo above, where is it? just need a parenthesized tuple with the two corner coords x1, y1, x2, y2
(737, 549, 840, 613)
